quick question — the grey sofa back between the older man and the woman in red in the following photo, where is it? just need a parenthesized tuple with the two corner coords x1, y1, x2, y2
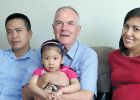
(91, 46, 114, 93)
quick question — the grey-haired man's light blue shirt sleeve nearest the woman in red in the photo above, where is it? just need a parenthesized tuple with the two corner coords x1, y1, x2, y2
(79, 49, 98, 95)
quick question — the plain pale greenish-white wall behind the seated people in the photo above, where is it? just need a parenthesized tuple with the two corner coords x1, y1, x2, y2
(0, 0, 140, 49)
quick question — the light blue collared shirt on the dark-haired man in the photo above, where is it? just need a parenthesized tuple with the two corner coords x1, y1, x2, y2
(0, 49, 39, 100)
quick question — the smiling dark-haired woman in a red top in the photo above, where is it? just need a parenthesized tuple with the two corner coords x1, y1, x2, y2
(109, 8, 140, 100)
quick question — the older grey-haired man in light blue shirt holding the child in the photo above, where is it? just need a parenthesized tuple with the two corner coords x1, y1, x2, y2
(23, 6, 98, 100)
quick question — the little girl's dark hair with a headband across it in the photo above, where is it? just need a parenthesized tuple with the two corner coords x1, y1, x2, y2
(41, 39, 64, 57)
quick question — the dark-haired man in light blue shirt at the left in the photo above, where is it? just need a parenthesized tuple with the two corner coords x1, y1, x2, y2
(0, 13, 38, 100)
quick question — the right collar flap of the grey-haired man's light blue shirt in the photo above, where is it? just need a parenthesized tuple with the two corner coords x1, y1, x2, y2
(67, 41, 78, 59)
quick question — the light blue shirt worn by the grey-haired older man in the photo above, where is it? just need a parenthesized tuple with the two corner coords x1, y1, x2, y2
(64, 41, 98, 94)
